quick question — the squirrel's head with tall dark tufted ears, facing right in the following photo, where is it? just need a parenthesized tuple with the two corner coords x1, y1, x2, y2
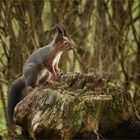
(54, 25, 72, 51)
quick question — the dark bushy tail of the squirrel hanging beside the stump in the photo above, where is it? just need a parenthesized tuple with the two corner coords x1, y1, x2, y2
(8, 76, 25, 130)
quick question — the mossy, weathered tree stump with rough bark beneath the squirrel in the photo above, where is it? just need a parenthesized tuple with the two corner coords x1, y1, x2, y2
(14, 73, 138, 139)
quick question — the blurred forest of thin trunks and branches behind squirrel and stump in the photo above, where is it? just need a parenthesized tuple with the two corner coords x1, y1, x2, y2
(0, 0, 140, 138)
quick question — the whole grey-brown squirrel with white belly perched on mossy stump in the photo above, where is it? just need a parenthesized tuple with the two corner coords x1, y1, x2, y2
(8, 25, 72, 129)
